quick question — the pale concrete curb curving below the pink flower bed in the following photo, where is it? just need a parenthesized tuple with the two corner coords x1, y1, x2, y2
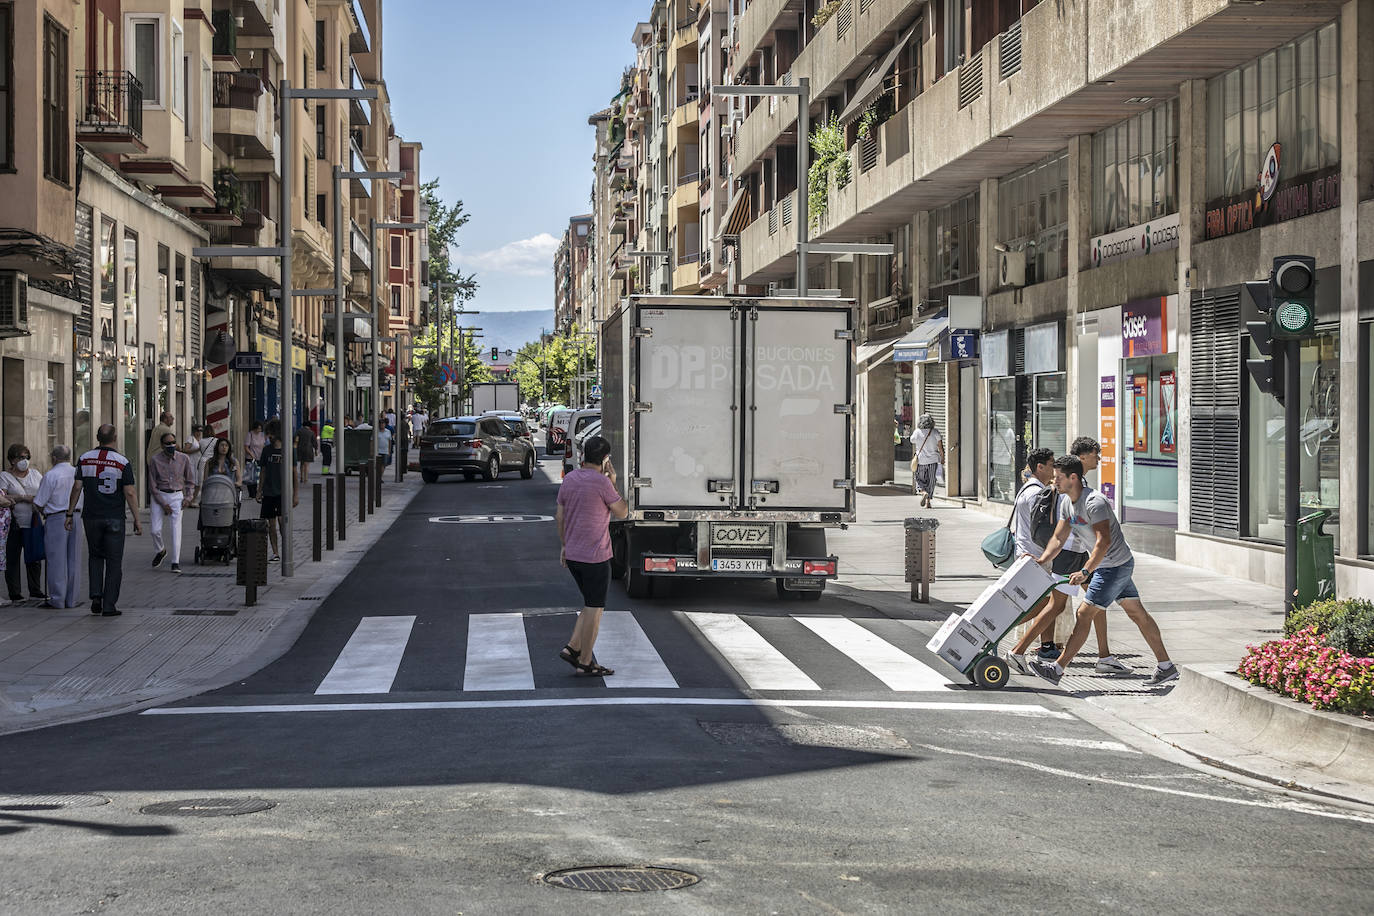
(1121, 665, 1374, 805)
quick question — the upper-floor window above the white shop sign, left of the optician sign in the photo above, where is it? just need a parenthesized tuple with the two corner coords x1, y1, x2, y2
(1092, 99, 1179, 235)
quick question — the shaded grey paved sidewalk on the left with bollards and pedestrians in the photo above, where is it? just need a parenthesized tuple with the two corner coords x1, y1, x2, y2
(0, 468, 422, 735)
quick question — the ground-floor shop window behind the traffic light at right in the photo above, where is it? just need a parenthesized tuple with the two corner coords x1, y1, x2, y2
(1245, 328, 1341, 552)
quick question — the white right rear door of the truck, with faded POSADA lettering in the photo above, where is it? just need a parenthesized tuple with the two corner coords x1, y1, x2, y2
(745, 305, 853, 511)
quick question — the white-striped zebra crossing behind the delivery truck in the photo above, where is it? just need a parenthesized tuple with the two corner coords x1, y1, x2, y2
(307, 611, 962, 696)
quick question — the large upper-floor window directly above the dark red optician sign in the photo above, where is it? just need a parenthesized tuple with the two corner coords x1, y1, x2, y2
(1206, 22, 1341, 198)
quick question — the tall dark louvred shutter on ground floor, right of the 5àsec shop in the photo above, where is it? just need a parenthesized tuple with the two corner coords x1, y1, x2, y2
(1189, 290, 1241, 538)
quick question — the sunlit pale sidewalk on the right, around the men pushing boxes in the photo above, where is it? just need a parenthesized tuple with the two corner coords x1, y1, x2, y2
(829, 488, 1374, 805)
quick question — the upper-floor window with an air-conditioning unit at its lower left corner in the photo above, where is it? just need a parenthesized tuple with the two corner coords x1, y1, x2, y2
(998, 151, 1069, 284)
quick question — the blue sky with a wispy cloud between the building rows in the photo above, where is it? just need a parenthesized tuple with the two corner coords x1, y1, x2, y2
(382, 0, 651, 312)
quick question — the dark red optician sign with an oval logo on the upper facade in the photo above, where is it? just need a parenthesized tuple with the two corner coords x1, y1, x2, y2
(1204, 143, 1341, 239)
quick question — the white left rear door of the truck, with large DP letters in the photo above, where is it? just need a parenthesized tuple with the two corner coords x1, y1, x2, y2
(629, 305, 739, 508)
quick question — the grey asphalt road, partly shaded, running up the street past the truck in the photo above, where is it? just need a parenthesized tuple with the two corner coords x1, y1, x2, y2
(0, 444, 1374, 915)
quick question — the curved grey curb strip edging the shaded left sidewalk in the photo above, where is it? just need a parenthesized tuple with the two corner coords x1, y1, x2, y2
(0, 486, 422, 736)
